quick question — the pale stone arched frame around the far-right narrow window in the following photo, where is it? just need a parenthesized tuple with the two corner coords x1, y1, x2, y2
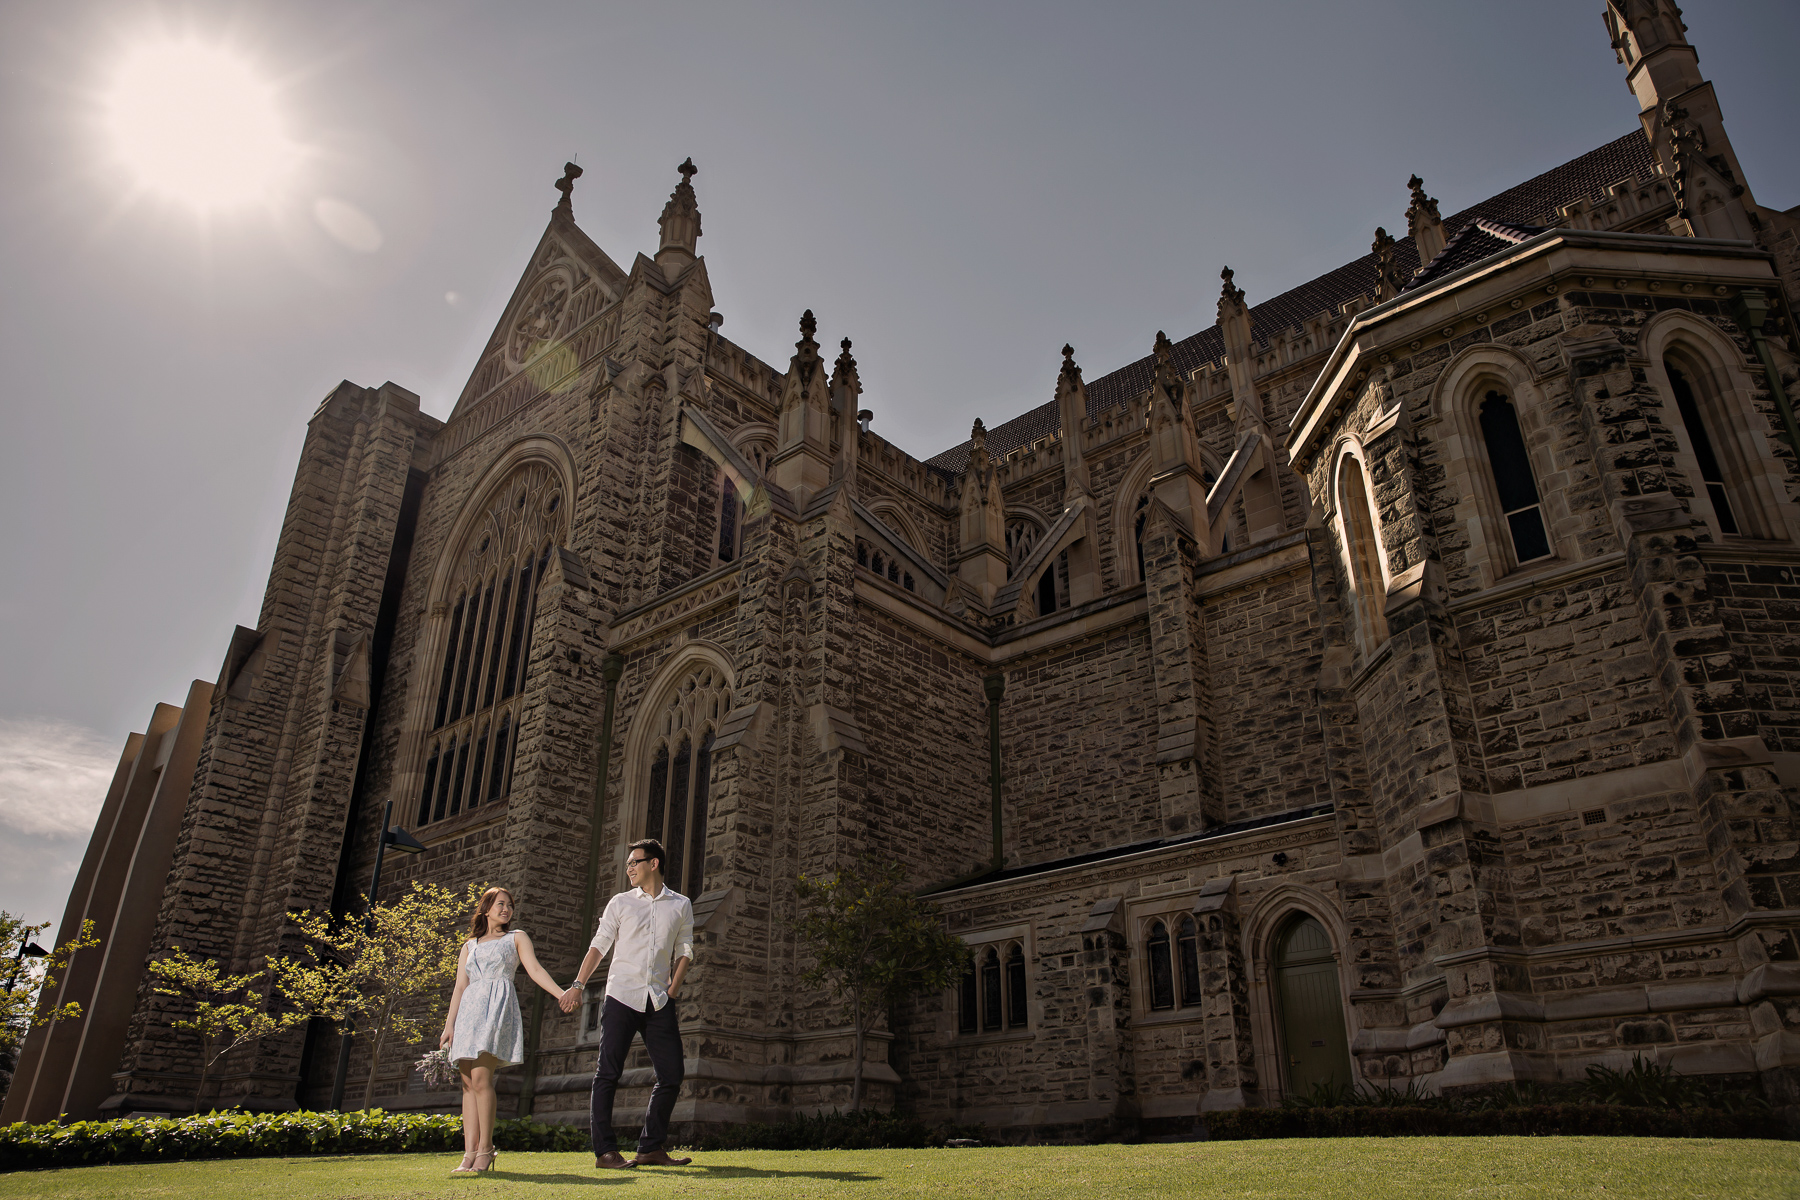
(1638, 311, 1800, 542)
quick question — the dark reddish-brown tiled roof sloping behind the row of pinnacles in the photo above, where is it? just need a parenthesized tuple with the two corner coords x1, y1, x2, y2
(925, 130, 1656, 475)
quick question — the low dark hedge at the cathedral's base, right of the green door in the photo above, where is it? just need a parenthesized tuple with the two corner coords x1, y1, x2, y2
(1204, 1105, 1791, 1141)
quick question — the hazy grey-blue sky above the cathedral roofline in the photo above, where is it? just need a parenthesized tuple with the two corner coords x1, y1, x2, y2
(0, 0, 1800, 921)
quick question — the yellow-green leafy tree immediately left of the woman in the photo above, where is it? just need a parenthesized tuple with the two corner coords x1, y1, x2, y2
(268, 882, 482, 1108)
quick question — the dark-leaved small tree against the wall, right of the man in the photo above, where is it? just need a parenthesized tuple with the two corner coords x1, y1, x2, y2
(794, 858, 968, 1108)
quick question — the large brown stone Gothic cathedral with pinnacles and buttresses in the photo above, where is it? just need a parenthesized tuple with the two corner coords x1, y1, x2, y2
(10, 0, 1800, 1135)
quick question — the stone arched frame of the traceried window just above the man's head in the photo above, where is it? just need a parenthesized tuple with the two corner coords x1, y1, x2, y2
(614, 642, 736, 900)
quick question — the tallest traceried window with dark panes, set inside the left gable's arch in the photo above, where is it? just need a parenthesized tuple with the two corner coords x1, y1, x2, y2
(418, 462, 567, 826)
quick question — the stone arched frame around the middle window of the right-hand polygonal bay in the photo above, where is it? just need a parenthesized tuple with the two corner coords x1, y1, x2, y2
(1422, 345, 1573, 594)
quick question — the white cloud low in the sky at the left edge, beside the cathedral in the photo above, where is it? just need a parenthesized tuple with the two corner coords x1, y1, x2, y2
(0, 718, 119, 838)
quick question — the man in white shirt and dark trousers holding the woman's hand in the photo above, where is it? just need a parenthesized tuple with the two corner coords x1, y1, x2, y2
(562, 838, 693, 1168)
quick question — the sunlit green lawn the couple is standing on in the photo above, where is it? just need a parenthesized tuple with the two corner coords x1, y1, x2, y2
(0, 1137, 1800, 1200)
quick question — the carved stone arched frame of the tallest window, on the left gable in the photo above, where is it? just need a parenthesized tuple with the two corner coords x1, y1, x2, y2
(391, 444, 576, 828)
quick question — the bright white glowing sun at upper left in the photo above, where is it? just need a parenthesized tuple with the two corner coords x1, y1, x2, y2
(104, 40, 299, 212)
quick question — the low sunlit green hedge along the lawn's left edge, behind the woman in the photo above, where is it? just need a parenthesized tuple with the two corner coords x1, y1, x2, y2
(0, 1108, 589, 1171)
